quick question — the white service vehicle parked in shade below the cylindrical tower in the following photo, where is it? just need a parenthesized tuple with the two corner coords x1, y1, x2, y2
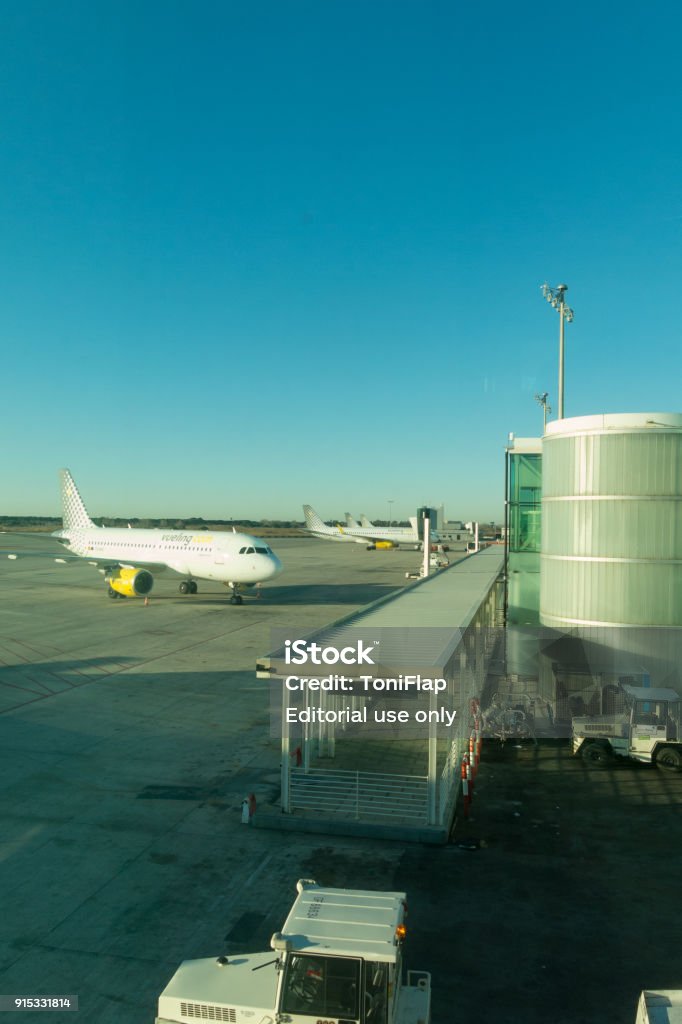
(572, 684, 682, 771)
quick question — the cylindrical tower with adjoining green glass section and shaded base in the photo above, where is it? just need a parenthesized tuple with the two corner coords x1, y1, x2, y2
(506, 413, 682, 725)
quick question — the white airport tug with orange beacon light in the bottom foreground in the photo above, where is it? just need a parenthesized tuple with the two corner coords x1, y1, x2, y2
(156, 879, 431, 1024)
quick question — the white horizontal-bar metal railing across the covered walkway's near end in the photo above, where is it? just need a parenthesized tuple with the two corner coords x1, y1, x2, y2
(290, 768, 428, 824)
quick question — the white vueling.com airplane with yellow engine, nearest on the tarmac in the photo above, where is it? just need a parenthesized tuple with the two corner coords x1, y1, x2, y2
(27, 469, 282, 604)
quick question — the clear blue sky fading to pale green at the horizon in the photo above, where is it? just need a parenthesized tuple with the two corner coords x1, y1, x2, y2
(0, 0, 682, 519)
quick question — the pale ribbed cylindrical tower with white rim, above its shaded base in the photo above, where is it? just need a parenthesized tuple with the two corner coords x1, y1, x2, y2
(540, 413, 682, 633)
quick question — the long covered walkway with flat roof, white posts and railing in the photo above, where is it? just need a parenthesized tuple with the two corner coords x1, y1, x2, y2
(254, 546, 504, 843)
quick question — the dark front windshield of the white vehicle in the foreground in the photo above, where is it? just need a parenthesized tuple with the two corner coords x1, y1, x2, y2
(280, 953, 360, 1021)
